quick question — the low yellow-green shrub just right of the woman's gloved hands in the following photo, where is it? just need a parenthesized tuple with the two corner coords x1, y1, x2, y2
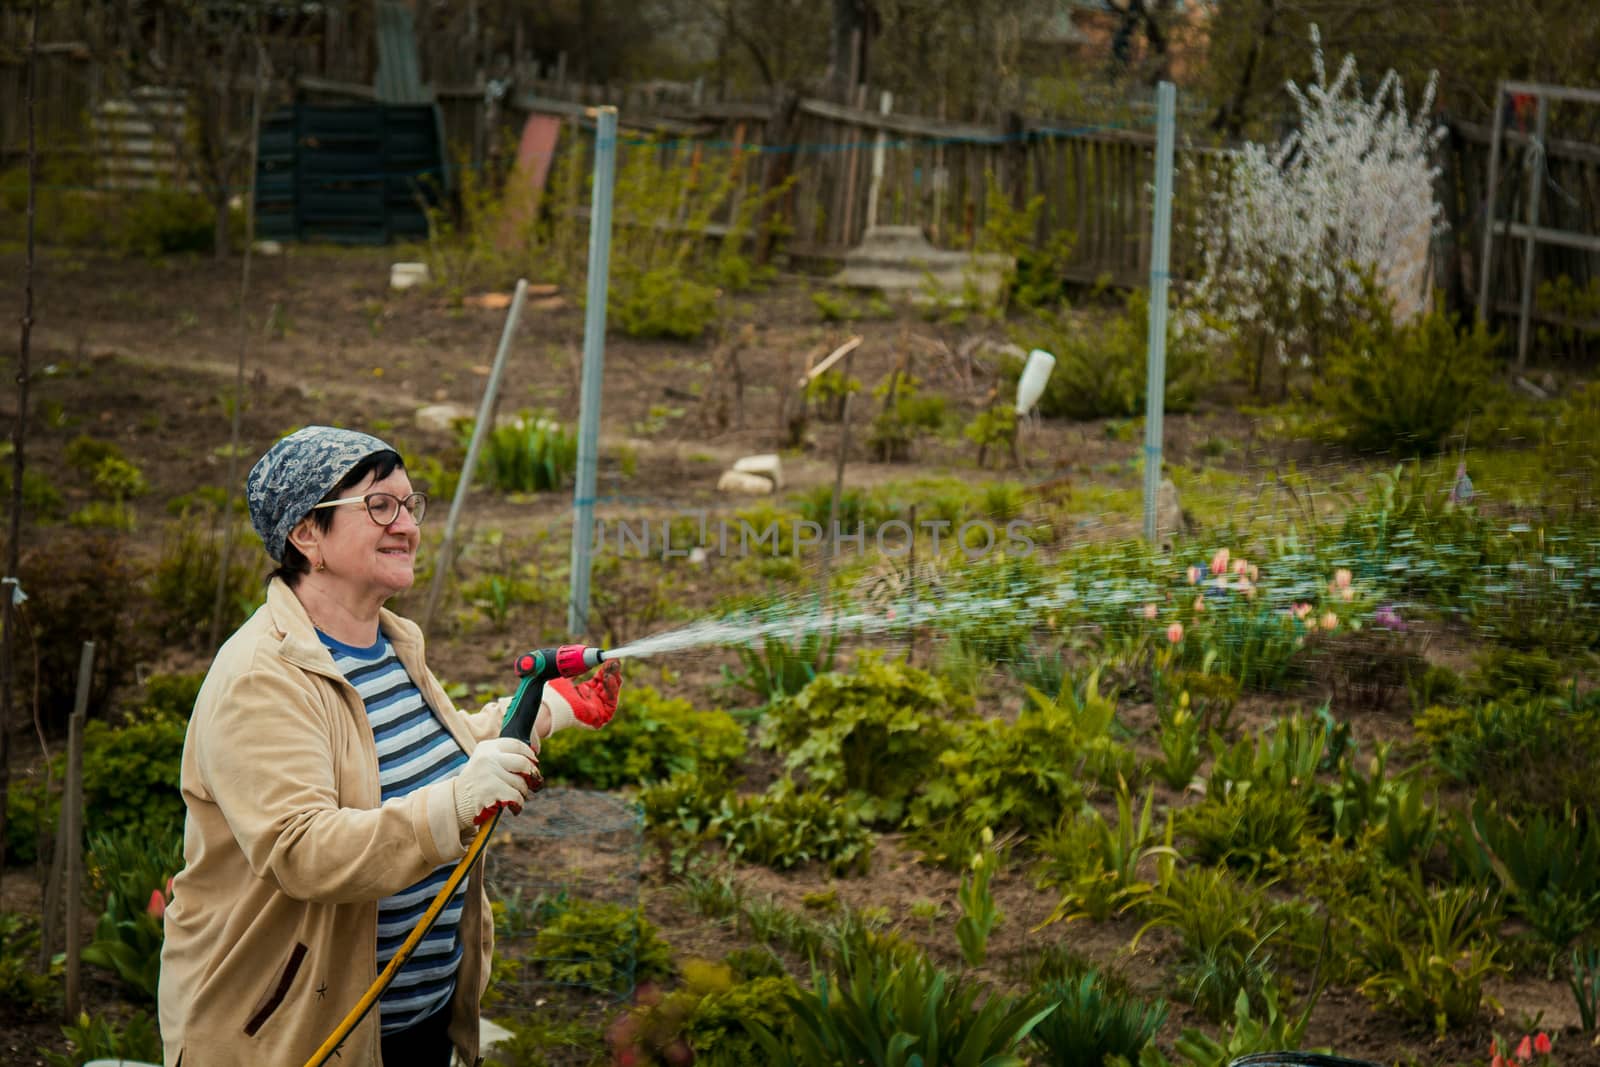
(539, 685, 746, 789)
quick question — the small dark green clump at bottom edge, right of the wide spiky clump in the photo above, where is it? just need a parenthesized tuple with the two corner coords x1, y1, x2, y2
(1032, 973, 1166, 1067)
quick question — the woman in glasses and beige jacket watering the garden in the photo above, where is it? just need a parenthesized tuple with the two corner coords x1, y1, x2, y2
(160, 426, 619, 1067)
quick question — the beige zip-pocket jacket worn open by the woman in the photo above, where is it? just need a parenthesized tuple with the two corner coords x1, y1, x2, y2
(160, 579, 501, 1067)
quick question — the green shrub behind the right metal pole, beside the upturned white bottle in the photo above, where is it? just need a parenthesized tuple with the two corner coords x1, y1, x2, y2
(1000, 290, 1210, 419)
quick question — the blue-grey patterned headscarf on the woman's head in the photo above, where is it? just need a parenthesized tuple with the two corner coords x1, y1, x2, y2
(245, 426, 403, 563)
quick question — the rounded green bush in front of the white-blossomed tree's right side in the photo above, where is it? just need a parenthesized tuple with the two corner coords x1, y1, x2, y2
(1318, 300, 1499, 456)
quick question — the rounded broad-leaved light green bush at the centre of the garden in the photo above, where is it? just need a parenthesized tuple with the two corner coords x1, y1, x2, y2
(762, 654, 965, 822)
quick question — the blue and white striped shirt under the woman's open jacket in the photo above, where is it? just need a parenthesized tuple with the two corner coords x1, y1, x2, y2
(317, 630, 467, 1035)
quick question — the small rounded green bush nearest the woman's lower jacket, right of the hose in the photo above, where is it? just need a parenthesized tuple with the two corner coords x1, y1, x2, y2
(533, 901, 672, 993)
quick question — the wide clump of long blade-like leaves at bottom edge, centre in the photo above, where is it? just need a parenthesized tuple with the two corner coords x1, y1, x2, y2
(755, 950, 1054, 1067)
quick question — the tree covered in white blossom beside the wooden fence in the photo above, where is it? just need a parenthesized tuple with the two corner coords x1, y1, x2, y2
(1192, 26, 1443, 390)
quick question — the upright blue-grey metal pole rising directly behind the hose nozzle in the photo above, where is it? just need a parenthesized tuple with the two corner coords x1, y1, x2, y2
(566, 106, 616, 637)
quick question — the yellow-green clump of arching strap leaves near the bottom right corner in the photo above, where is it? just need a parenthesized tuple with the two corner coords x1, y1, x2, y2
(1350, 870, 1506, 1035)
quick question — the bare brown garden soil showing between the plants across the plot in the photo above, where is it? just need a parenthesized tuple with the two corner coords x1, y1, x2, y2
(0, 246, 1600, 1065)
